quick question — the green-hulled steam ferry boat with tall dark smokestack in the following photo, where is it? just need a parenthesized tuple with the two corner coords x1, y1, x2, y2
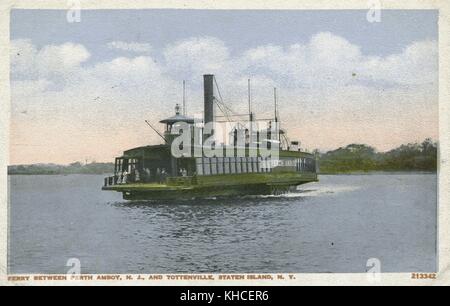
(102, 74, 318, 200)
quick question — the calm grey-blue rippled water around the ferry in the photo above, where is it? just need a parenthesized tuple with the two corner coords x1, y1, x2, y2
(9, 174, 437, 274)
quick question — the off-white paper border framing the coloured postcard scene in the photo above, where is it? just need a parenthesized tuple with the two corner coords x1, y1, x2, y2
(0, 0, 450, 286)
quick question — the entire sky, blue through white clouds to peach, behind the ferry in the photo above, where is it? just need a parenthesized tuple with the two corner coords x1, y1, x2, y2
(10, 10, 438, 164)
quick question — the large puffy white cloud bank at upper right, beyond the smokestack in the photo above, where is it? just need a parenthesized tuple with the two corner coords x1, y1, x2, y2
(240, 33, 438, 88)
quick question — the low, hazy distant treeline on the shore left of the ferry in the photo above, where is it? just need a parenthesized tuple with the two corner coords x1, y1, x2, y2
(8, 162, 114, 175)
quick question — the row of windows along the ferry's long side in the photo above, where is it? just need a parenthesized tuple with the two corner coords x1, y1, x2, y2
(196, 157, 315, 175)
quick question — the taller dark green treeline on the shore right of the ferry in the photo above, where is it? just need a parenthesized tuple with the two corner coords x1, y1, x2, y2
(320, 139, 438, 173)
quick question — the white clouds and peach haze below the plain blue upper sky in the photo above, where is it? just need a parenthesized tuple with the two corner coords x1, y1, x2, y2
(11, 32, 438, 163)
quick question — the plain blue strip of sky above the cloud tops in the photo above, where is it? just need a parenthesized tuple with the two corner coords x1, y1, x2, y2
(11, 9, 438, 61)
